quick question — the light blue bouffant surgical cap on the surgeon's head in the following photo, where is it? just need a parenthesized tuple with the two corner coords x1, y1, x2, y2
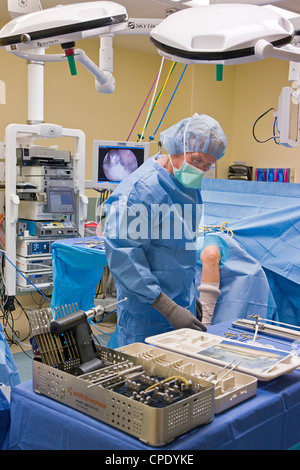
(160, 113, 227, 160)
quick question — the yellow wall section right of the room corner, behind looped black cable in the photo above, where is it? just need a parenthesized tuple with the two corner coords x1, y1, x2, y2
(231, 59, 300, 183)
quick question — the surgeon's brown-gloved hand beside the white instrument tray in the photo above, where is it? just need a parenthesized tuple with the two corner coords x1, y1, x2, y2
(152, 292, 206, 331)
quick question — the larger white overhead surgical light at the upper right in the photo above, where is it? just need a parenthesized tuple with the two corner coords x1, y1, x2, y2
(150, 4, 300, 64)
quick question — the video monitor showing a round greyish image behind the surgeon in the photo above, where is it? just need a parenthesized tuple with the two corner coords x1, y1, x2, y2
(93, 140, 149, 185)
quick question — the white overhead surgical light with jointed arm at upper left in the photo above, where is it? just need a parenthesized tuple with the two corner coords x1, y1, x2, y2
(0, 1, 128, 93)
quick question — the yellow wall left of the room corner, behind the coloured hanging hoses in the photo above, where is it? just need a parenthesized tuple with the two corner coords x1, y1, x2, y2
(0, 33, 234, 183)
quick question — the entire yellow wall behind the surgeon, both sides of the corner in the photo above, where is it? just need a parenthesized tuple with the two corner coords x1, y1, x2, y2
(0, 34, 300, 179)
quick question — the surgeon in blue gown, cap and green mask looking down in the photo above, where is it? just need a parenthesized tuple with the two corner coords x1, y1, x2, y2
(104, 114, 227, 346)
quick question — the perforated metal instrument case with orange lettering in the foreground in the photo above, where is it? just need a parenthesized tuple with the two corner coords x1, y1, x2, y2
(33, 346, 214, 446)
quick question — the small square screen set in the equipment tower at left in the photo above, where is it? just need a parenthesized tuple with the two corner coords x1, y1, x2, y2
(47, 186, 75, 214)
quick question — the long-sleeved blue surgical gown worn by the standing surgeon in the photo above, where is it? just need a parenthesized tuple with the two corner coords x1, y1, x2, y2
(104, 156, 202, 346)
